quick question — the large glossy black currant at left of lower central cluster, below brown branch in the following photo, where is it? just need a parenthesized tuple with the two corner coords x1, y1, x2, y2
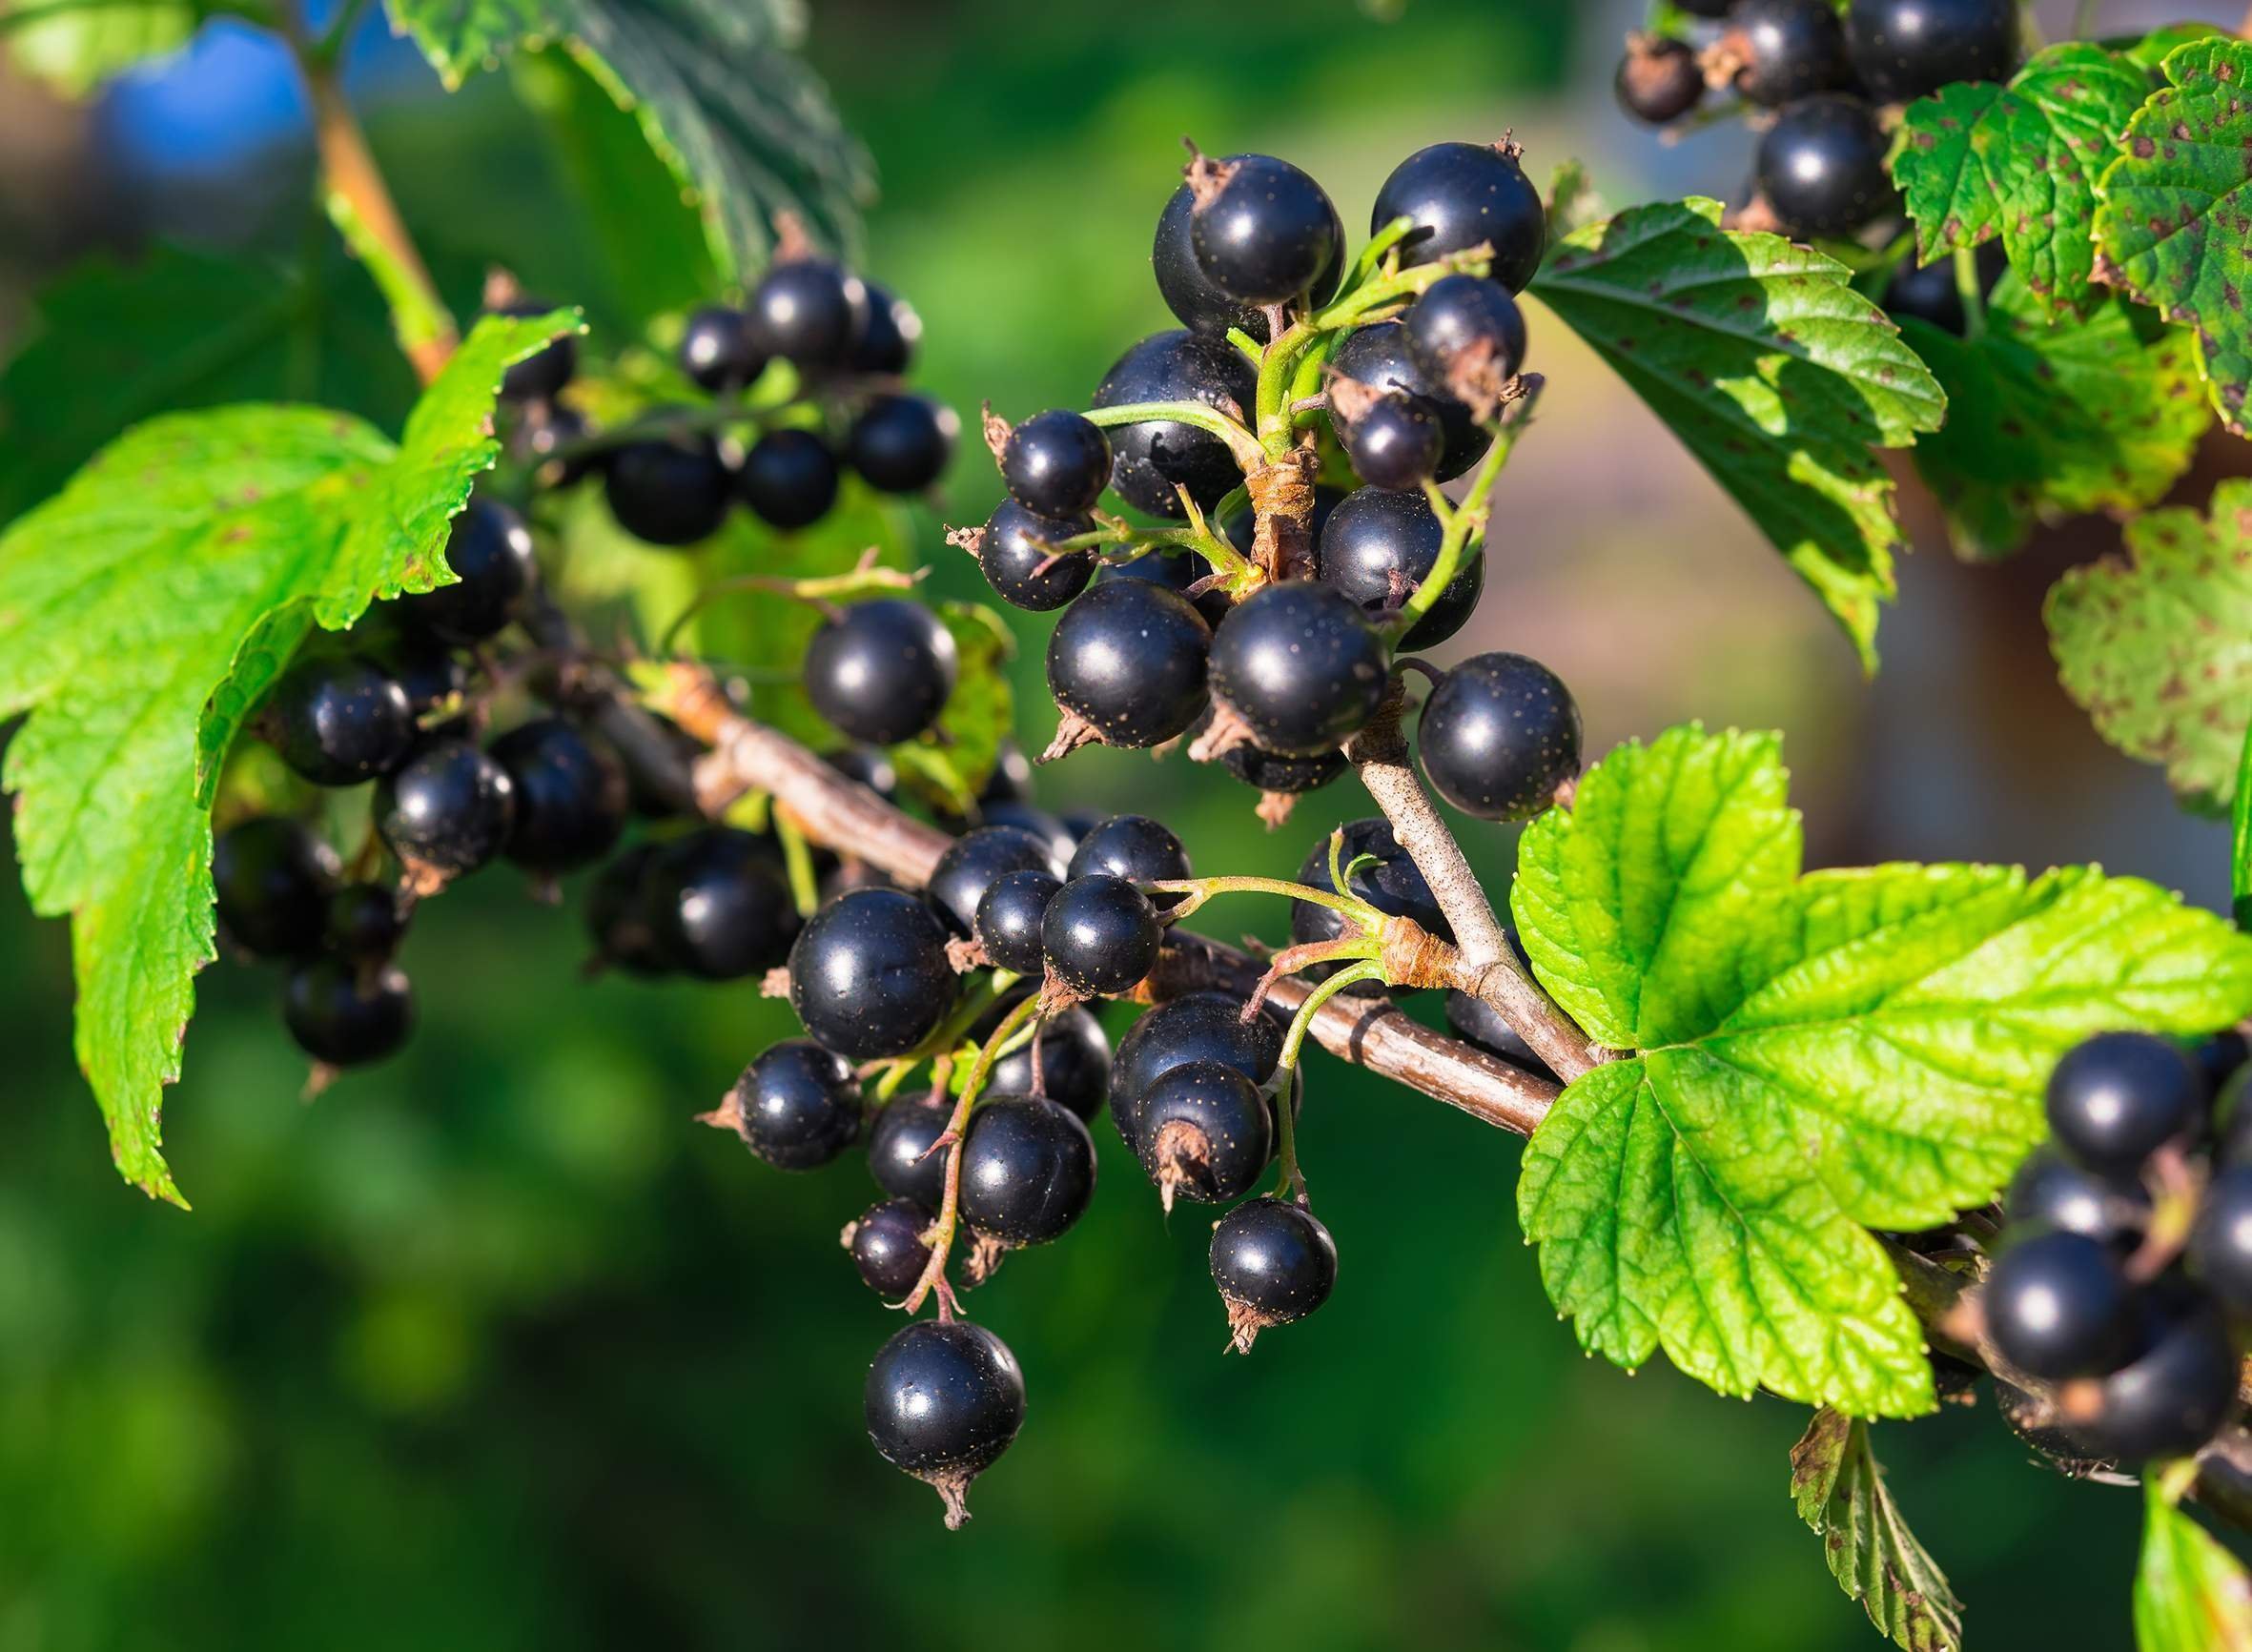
(790, 889, 957, 1060)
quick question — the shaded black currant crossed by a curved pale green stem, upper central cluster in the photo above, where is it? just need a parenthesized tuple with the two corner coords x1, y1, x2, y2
(1095, 331, 1259, 518)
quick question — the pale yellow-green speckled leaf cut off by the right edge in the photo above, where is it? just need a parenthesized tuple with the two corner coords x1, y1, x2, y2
(2045, 479, 2252, 810)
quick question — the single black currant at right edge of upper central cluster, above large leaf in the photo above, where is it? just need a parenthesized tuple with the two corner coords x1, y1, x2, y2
(1417, 653, 1579, 819)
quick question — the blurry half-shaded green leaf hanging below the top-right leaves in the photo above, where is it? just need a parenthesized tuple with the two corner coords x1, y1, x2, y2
(1901, 273, 2211, 559)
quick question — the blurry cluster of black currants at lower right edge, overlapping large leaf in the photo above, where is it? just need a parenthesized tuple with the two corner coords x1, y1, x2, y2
(1979, 1033, 2252, 1472)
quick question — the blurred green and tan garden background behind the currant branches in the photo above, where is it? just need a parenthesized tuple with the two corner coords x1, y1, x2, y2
(0, 0, 2243, 1652)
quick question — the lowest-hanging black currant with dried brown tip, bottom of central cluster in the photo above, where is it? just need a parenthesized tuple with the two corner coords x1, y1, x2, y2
(865, 1319, 1025, 1531)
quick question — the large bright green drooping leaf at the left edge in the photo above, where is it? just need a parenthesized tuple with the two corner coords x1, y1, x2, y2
(0, 317, 565, 1202)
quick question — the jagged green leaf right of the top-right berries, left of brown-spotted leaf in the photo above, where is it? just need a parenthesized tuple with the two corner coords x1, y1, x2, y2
(1892, 40, 2151, 316)
